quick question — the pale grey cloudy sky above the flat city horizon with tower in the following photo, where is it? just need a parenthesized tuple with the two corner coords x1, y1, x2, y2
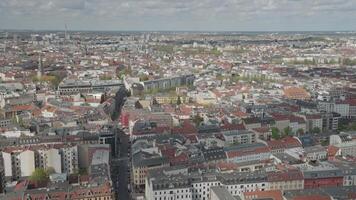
(0, 0, 356, 31)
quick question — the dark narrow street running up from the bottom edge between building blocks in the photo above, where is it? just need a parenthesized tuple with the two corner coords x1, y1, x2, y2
(112, 130, 130, 200)
